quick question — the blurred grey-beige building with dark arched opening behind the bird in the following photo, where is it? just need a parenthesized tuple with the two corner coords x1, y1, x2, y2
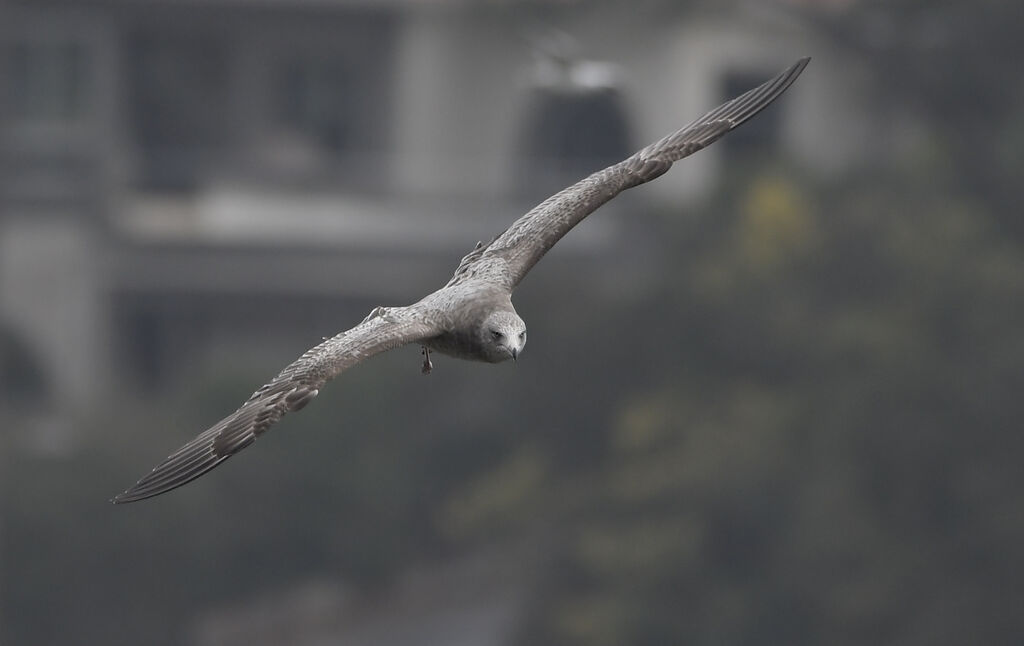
(0, 0, 871, 432)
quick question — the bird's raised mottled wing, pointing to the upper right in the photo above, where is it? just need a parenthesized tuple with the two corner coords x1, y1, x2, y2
(450, 58, 810, 290)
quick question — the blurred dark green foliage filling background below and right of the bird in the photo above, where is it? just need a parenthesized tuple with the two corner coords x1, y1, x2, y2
(0, 0, 1024, 646)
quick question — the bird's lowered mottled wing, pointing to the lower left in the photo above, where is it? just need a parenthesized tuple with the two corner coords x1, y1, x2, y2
(113, 305, 437, 504)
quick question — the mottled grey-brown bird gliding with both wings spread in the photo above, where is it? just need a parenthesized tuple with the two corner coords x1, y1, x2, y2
(113, 58, 810, 503)
